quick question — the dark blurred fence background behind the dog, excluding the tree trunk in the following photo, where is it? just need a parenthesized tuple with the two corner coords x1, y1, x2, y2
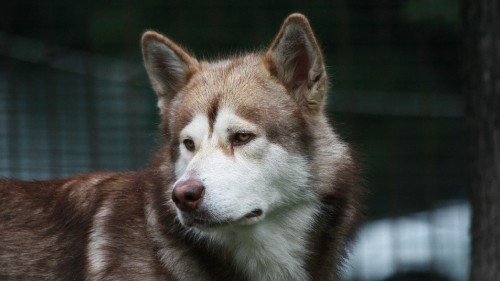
(0, 0, 470, 281)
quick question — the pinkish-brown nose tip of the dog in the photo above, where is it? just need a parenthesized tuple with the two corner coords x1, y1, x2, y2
(172, 180, 205, 212)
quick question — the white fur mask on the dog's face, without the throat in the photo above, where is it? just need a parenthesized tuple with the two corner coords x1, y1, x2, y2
(176, 108, 310, 225)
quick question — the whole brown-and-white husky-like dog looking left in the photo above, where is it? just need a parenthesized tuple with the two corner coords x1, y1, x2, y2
(0, 14, 362, 281)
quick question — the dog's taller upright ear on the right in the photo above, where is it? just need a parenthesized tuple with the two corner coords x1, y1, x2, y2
(266, 14, 327, 115)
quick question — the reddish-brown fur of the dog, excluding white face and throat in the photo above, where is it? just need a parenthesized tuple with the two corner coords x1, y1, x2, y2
(0, 14, 361, 280)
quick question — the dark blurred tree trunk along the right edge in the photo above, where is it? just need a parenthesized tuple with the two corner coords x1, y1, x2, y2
(463, 0, 500, 281)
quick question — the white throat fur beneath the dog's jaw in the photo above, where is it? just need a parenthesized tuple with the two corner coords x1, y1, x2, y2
(202, 200, 317, 281)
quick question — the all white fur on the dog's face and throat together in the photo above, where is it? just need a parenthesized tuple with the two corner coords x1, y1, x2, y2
(176, 108, 318, 280)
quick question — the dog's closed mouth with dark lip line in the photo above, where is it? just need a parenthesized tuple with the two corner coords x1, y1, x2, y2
(185, 209, 264, 228)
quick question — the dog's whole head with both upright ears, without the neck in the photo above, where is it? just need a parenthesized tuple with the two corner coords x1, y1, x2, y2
(142, 14, 327, 228)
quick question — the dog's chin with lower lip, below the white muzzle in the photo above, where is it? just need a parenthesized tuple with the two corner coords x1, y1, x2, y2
(177, 209, 264, 231)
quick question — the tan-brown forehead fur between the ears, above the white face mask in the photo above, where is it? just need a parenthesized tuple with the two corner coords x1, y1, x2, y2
(169, 55, 307, 153)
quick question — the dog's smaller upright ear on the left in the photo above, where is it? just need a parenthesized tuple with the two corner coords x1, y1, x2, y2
(141, 31, 198, 100)
